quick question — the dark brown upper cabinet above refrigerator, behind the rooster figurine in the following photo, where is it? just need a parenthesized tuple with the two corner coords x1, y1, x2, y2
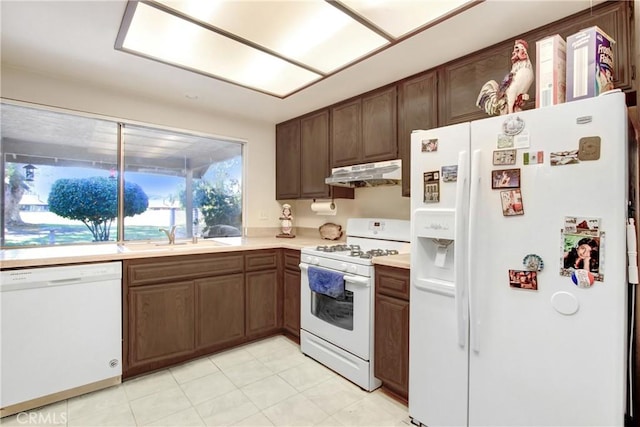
(438, 1, 633, 126)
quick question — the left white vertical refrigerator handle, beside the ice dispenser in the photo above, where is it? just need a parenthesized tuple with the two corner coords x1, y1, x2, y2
(454, 151, 469, 348)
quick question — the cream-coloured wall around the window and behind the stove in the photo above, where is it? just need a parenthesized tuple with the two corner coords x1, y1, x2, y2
(0, 64, 410, 232)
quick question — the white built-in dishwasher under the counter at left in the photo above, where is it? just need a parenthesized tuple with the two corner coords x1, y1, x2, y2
(0, 262, 122, 416)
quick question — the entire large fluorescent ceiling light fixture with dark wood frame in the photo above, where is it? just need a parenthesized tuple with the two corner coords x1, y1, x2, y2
(115, 0, 478, 98)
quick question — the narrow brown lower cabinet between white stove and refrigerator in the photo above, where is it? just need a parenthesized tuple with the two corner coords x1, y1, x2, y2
(374, 265, 409, 400)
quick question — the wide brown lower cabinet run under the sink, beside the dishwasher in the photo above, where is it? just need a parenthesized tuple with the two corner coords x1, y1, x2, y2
(123, 249, 286, 378)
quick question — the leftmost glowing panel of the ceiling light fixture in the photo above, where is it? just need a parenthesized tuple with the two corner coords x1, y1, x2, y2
(116, 2, 322, 97)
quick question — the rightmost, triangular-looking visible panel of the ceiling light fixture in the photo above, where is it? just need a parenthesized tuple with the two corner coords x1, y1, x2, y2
(340, 0, 477, 38)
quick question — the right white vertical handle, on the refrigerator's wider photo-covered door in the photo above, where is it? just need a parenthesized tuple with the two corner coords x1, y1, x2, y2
(467, 150, 482, 353)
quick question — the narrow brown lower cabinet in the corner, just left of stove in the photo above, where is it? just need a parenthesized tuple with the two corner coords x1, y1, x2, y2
(282, 249, 300, 338)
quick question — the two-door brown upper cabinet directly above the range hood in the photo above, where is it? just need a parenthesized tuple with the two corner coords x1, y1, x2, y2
(330, 85, 398, 168)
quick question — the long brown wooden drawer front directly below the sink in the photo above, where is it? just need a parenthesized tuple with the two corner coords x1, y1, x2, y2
(127, 254, 243, 286)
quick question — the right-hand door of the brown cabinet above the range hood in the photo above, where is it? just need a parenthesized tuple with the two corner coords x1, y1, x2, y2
(360, 85, 398, 163)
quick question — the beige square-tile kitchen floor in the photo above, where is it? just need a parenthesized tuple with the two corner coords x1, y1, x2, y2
(0, 336, 410, 427)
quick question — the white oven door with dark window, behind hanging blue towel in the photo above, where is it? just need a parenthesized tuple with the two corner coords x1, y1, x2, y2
(300, 263, 373, 361)
